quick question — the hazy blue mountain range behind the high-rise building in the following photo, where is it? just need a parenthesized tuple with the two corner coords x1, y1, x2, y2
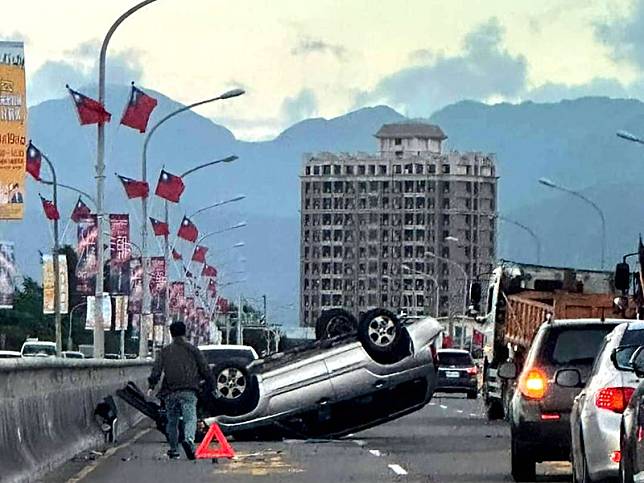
(18, 87, 644, 323)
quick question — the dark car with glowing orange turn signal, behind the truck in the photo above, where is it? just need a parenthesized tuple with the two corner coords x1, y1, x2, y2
(499, 319, 623, 481)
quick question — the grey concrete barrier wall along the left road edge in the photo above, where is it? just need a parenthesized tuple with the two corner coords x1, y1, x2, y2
(0, 359, 151, 482)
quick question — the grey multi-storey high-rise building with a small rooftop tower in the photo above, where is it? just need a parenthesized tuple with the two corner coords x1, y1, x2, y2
(300, 123, 497, 326)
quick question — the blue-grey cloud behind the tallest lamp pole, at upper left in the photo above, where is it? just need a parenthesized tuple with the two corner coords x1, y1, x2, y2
(28, 40, 143, 105)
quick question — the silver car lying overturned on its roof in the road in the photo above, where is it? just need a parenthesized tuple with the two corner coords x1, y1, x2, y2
(203, 309, 442, 438)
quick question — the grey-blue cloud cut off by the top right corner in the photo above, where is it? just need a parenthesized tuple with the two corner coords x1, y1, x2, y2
(594, 0, 644, 70)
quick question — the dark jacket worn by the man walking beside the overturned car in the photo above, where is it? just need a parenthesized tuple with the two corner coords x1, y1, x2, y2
(148, 337, 212, 395)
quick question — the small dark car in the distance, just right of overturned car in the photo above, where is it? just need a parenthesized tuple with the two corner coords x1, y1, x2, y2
(435, 349, 478, 399)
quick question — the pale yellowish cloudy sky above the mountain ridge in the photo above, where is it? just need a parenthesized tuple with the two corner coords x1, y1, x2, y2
(0, 0, 644, 141)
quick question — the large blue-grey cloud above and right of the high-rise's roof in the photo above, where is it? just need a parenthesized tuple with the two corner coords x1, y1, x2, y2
(356, 18, 526, 116)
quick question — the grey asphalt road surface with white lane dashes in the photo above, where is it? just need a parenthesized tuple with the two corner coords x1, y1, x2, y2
(44, 395, 570, 483)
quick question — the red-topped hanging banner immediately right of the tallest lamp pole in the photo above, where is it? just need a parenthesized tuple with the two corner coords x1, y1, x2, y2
(110, 214, 132, 295)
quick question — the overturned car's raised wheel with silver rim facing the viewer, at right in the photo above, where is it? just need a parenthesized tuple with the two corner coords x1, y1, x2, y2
(358, 309, 403, 360)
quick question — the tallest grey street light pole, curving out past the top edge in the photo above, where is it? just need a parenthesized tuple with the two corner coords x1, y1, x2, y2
(94, 0, 156, 359)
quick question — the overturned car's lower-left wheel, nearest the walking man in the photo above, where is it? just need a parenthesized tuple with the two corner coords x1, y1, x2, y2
(212, 359, 259, 416)
